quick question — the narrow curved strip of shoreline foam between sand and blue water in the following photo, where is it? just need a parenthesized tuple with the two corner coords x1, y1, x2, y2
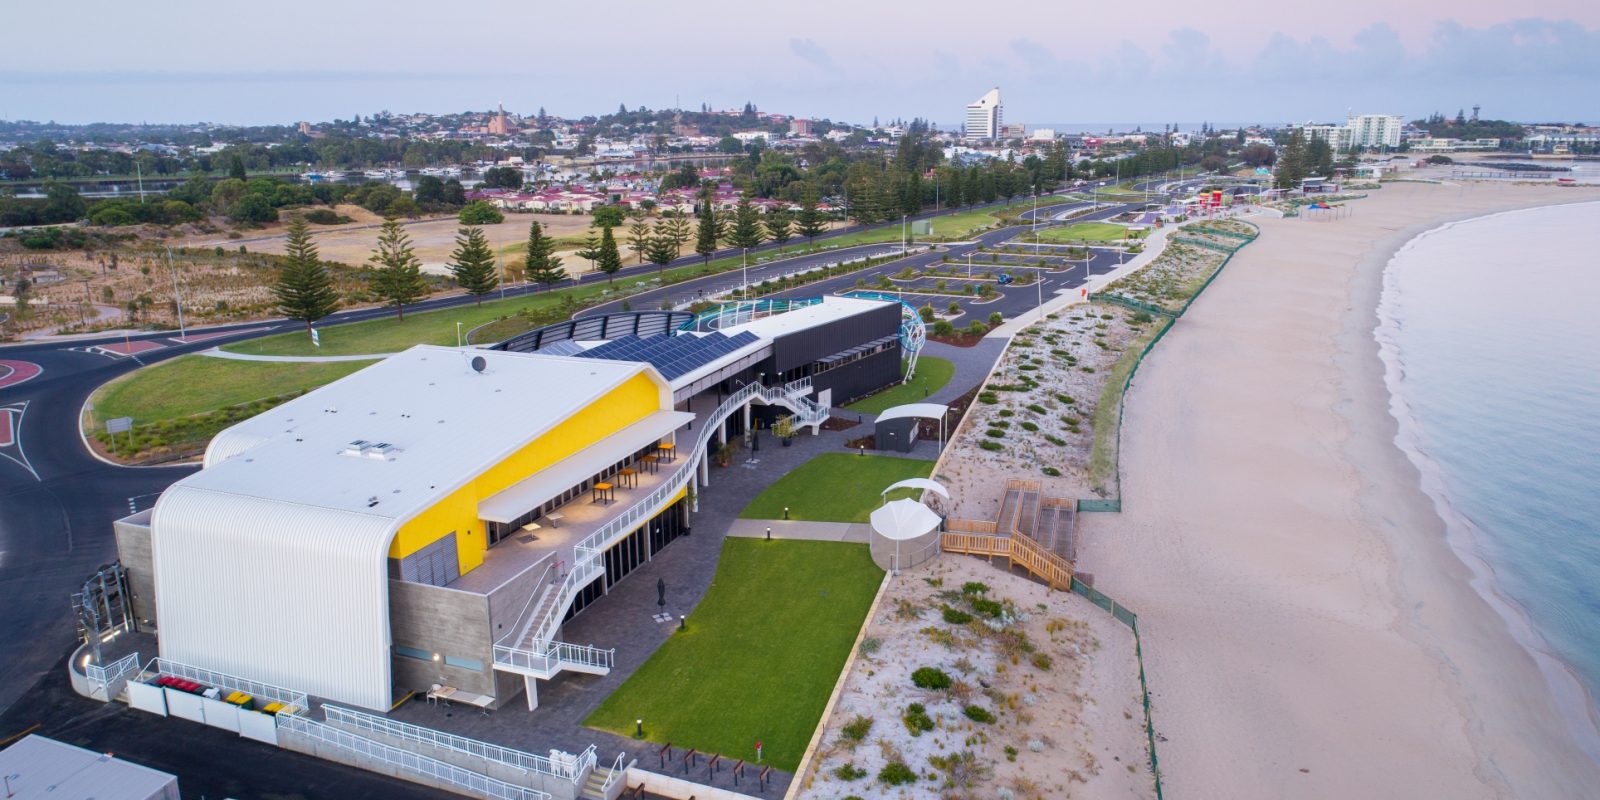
(1373, 203, 1600, 762)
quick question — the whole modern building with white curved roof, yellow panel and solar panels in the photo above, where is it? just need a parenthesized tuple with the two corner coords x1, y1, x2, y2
(117, 298, 915, 710)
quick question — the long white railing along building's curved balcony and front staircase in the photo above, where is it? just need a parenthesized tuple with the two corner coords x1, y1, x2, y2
(494, 384, 761, 672)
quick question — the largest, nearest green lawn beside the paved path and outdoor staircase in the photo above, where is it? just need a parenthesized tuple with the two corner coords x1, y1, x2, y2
(584, 539, 883, 771)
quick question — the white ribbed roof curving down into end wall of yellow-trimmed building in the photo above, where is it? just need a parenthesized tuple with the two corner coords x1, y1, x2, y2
(150, 346, 672, 710)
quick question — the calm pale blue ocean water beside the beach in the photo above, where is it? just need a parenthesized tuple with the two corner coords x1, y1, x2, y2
(1376, 202, 1600, 742)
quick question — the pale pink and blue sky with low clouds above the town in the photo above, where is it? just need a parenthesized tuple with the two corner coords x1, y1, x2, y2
(0, 0, 1600, 126)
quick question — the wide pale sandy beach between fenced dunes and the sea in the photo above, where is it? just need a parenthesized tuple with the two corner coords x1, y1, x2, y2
(1078, 184, 1600, 798)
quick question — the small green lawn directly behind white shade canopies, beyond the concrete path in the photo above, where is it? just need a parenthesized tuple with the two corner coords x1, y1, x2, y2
(739, 453, 933, 522)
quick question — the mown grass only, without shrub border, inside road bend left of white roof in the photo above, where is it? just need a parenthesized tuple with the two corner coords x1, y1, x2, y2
(93, 355, 373, 424)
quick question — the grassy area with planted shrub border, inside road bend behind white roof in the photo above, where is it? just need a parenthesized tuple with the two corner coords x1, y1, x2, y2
(86, 355, 371, 458)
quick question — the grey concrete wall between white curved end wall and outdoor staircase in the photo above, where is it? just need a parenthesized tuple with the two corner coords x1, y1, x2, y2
(389, 581, 501, 707)
